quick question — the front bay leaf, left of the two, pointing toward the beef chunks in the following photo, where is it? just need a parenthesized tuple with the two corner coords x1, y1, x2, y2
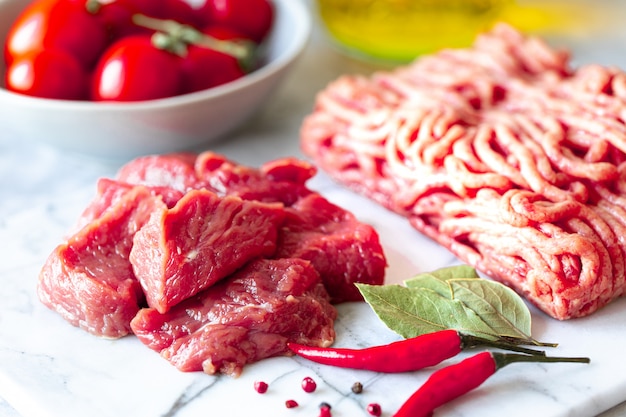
(357, 284, 497, 340)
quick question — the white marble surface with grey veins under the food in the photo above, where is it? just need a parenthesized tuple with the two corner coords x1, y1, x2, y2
(0, 1, 626, 417)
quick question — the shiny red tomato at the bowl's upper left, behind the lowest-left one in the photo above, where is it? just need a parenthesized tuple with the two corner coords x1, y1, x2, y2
(5, 0, 107, 68)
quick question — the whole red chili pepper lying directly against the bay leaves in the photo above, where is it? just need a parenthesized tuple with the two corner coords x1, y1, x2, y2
(287, 330, 542, 373)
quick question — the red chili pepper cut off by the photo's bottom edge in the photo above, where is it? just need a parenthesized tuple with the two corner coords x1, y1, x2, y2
(393, 352, 589, 417)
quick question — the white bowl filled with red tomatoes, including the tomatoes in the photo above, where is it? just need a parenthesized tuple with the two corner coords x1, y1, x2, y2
(0, 0, 311, 158)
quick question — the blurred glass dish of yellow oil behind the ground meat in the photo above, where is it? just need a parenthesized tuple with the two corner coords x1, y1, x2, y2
(309, 0, 626, 63)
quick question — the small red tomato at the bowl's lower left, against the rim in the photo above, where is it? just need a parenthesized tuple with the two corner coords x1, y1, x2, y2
(5, 49, 88, 100)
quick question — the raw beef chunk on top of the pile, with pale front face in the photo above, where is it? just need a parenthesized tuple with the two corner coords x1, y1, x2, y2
(130, 190, 284, 313)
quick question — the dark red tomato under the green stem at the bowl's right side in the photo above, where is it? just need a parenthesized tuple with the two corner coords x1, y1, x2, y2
(181, 27, 245, 93)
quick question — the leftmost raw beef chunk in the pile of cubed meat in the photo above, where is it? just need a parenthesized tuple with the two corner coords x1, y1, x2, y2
(37, 187, 163, 338)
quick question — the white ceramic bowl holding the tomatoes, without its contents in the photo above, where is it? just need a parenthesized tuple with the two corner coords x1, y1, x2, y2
(0, 0, 311, 158)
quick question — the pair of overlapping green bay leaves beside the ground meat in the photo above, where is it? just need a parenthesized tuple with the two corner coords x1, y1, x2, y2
(359, 265, 541, 344)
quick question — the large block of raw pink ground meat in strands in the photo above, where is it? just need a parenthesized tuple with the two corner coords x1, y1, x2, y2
(301, 24, 626, 320)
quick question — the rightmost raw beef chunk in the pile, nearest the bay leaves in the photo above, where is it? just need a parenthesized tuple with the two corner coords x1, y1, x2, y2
(276, 194, 387, 302)
